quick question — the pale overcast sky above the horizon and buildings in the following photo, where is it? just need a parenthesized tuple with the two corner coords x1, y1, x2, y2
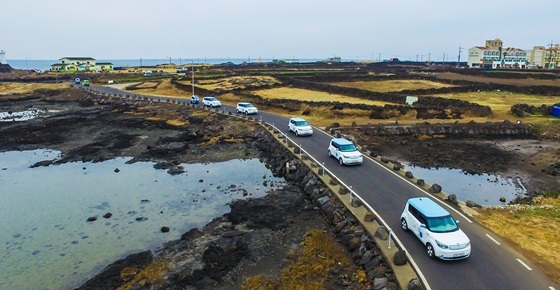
(0, 0, 560, 61)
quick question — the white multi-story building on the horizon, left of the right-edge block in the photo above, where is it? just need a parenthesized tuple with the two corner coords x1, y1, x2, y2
(467, 38, 528, 69)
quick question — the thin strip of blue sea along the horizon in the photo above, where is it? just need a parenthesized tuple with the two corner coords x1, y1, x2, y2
(6, 58, 332, 70)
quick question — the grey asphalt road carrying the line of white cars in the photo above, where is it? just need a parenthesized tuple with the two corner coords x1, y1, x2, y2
(92, 87, 560, 290)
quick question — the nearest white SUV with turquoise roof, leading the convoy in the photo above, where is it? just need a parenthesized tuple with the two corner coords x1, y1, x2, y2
(401, 197, 471, 260)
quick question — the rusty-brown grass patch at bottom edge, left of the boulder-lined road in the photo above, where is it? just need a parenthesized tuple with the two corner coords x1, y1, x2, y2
(241, 230, 367, 290)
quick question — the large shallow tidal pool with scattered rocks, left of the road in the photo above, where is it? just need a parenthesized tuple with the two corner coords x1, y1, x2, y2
(0, 150, 285, 289)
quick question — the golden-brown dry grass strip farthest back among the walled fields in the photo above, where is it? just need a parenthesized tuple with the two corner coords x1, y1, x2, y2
(331, 80, 455, 93)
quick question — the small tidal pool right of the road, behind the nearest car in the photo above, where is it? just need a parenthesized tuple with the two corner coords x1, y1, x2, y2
(405, 165, 527, 205)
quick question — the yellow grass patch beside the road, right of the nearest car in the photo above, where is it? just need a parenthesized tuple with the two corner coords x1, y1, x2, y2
(474, 194, 560, 283)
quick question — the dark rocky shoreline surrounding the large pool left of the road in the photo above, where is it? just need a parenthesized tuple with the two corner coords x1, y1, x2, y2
(0, 89, 398, 289)
